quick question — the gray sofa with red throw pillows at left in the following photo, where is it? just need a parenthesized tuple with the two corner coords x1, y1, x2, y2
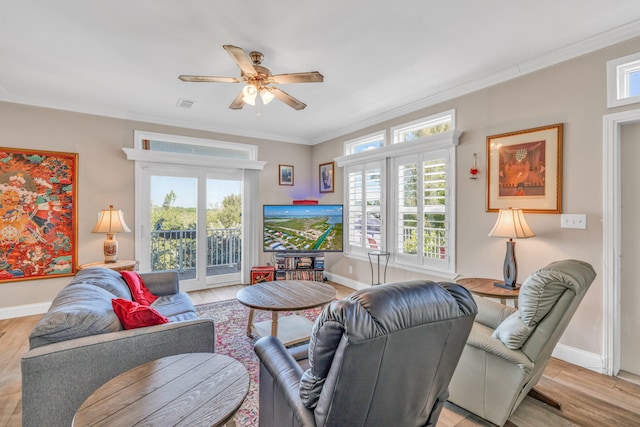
(22, 268, 215, 427)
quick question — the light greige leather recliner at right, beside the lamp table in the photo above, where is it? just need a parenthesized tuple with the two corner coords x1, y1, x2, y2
(449, 260, 596, 426)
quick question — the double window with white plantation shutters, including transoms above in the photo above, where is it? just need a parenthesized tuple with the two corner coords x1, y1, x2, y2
(334, 110, 461, 278)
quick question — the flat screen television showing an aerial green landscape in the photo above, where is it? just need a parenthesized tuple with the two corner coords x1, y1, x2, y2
(262, 205, 343, 252)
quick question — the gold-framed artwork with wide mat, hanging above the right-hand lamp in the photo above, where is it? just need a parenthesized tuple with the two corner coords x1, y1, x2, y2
(487, 123, 563, 214)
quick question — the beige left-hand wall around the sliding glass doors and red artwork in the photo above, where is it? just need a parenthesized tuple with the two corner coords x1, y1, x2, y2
(0, 102, 314, 313)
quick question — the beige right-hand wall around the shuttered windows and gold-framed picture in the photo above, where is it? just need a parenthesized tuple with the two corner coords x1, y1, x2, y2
(312, 39, 640, 355)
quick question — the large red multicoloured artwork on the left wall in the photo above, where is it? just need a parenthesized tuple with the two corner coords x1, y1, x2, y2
(0, 147, 78, 283)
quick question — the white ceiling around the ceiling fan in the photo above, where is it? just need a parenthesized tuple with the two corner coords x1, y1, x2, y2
(0, 0, 640, 144)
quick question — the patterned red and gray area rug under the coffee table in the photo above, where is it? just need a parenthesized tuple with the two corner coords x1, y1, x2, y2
(196, 300, 322, 427)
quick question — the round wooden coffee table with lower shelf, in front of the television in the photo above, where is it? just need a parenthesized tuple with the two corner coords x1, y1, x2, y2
(236, 280, 336, 346)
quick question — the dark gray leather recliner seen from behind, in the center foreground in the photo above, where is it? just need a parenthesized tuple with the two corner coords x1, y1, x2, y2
(255, 280, 477, 427)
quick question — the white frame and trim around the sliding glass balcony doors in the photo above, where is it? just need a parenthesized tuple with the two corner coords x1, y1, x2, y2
(122, 131, 266, 291)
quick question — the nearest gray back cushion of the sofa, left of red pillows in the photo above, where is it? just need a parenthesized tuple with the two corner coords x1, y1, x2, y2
(29, 283, 122, 349)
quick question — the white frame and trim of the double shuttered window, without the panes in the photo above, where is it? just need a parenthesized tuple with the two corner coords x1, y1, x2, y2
(334, 110, 462, 279)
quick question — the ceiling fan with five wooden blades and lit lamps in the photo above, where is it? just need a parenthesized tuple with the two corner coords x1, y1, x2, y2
(178, 45, 324, 110)
